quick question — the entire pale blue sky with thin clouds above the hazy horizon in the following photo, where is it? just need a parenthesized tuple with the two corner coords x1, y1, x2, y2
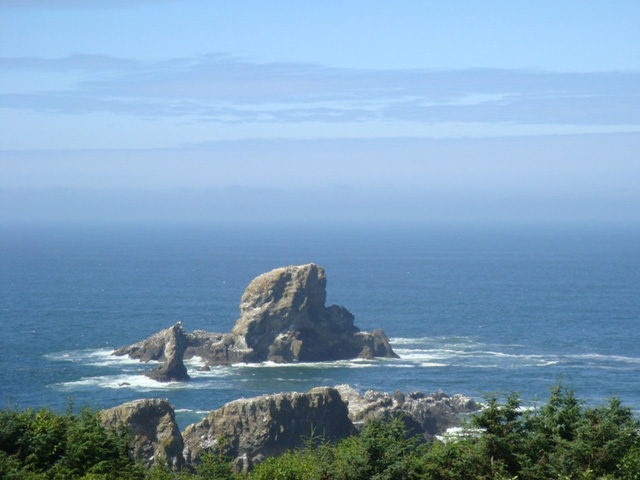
(0, 0, 640, 226)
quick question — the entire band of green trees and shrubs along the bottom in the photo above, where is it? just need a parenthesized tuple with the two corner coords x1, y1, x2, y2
(0, 386, 640, 480)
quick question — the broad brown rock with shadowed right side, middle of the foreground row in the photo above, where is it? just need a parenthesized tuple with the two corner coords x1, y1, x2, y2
(183, 387, 355, 472)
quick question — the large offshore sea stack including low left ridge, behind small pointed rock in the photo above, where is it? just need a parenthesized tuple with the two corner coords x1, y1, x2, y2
(114, 264, 397, 365)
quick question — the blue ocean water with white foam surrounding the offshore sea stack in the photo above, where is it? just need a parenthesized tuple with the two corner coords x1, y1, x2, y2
(0, 225, 640, 426)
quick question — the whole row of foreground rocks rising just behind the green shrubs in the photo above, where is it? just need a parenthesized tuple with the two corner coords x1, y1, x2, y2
(101, 385, 478, 472)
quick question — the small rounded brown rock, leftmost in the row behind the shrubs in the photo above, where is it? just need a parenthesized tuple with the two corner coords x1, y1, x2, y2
(100, 399, 184, 470)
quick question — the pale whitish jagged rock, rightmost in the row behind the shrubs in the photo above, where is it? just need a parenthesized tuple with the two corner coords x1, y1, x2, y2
(336, 385, 479, 440)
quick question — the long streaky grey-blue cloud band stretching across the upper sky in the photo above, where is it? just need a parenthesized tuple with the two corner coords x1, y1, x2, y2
(0, 55, 640, 126)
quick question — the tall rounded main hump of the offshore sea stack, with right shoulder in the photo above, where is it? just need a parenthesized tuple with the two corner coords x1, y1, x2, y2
(232, 263, 396, 362)
